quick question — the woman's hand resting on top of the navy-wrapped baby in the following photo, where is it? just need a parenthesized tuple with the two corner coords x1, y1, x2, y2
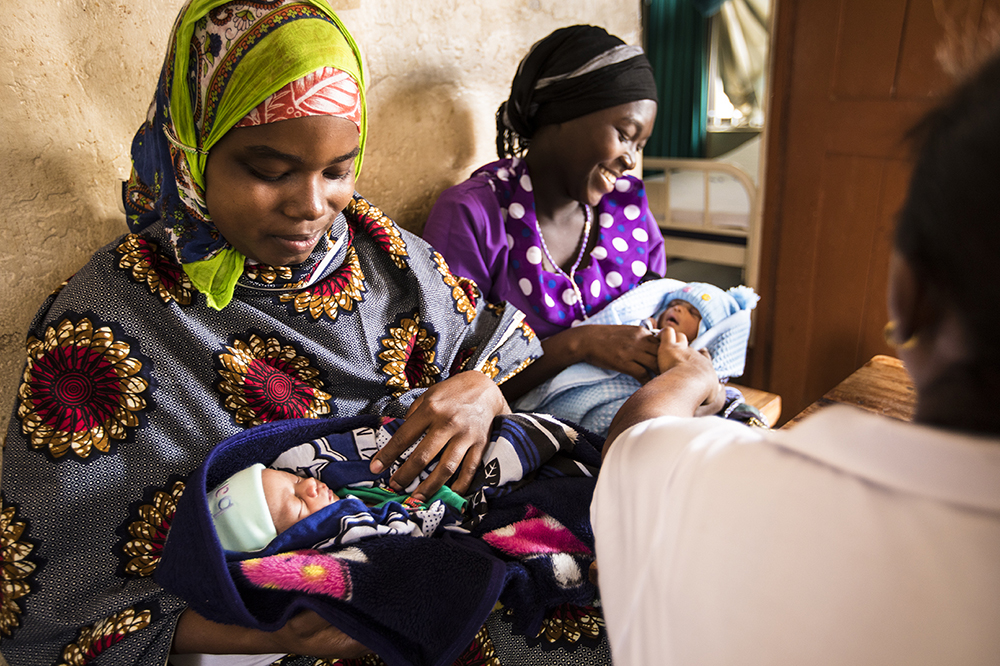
(371, 371, 510, 499)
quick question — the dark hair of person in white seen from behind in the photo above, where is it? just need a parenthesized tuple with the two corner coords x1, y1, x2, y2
(895, 53, 1000, 366)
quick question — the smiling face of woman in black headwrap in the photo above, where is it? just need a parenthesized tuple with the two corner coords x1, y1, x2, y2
(551, 99, 656, 206)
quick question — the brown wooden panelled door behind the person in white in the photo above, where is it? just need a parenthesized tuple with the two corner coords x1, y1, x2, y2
(744, 0, 997, 419)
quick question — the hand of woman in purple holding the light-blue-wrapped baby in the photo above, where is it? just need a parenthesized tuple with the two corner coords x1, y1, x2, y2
(572, 325, 660, 384)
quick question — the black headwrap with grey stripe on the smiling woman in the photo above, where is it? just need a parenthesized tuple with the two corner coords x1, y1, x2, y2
(497, 25, 657, 158)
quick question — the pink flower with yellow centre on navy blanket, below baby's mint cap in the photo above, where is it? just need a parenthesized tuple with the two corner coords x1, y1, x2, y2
(241, 549, 364, 601)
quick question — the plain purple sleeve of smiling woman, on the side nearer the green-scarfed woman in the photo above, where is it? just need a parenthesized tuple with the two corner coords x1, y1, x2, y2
(423, 180, 508, 302)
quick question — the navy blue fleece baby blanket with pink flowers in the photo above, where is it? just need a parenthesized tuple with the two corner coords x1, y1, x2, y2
(155, 414, 603, 666)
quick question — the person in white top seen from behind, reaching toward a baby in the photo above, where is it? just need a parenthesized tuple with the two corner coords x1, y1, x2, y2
(591, 48, 1000, 666)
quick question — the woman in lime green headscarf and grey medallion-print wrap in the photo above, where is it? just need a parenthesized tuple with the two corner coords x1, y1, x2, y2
(0, 0, 552, 664)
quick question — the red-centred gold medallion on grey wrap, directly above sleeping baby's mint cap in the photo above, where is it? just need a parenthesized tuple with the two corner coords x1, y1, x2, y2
(217, 333, 332, 428)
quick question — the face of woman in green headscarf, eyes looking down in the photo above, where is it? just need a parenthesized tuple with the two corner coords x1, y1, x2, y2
(205, 116, 359, 266)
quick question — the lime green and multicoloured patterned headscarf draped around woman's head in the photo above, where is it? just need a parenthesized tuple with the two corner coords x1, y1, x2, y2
(123, 0, 368, 309)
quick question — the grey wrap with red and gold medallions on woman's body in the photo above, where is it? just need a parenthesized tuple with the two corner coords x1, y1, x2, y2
(0, 195, 541, 664)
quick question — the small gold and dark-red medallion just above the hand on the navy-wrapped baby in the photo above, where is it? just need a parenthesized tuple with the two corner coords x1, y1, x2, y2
(378, 312, 441, 395)
